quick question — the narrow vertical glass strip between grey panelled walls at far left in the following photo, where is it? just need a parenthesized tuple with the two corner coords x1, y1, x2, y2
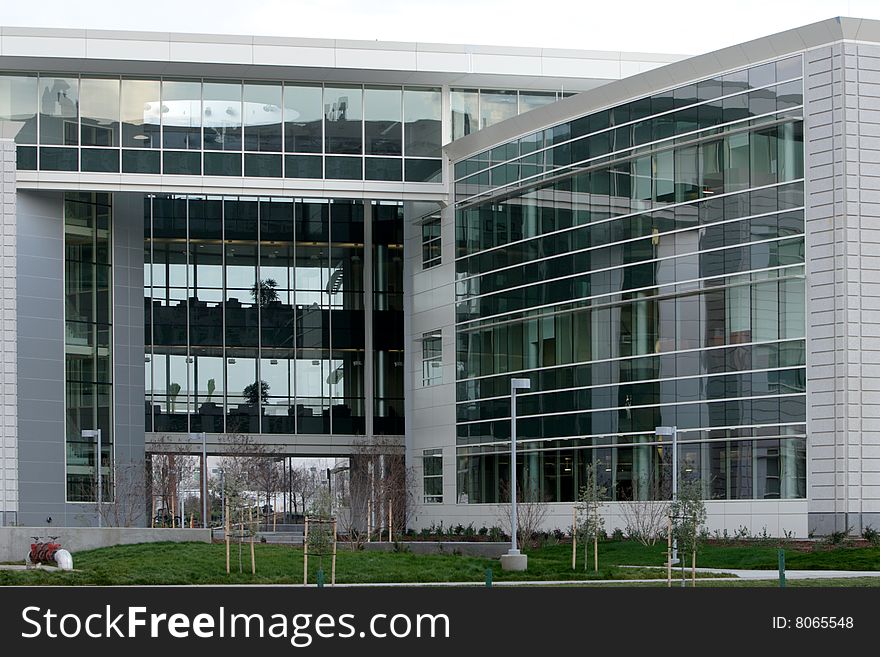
(64, 192, 113, 502)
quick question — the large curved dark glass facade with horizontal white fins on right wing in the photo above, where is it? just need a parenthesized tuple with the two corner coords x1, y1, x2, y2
(454, 57, 806, 503)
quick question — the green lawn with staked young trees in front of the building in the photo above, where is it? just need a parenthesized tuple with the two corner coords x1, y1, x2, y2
(0, 541, 880, 586)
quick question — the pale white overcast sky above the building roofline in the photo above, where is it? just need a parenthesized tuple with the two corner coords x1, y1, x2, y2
(0, 0, 880, 54)
